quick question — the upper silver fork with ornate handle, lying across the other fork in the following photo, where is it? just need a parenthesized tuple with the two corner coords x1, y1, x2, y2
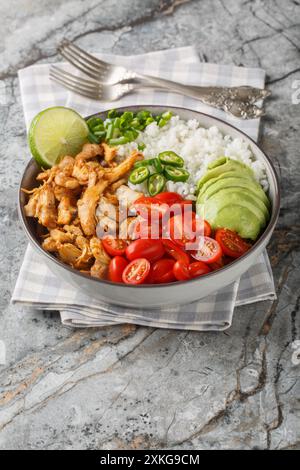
(58, 41, 270, 119)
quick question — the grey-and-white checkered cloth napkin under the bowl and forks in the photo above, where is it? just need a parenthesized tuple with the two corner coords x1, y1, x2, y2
(12, 47, 276, 331)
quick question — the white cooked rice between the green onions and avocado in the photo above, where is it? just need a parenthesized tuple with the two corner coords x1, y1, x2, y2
(118, 116, 268, 199)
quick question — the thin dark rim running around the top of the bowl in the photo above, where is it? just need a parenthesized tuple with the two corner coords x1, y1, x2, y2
(18, 104, 280, 289)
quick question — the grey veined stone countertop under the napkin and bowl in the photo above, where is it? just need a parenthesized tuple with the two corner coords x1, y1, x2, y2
(0, 0, 300, 449)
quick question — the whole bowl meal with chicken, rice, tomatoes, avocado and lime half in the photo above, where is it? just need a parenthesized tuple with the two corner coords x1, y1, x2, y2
(20, 106, 279, 307)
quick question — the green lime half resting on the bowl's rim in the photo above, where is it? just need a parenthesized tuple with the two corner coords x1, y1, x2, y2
(28, 106, 89, 168)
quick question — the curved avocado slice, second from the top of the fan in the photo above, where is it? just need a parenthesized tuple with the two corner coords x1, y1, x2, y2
(197, 172, 270, 209)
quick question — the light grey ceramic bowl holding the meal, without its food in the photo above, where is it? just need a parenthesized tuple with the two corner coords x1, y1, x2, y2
(19, 105, 280, 308)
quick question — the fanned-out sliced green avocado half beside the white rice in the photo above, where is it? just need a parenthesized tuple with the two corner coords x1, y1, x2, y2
(196, 157, 271, 240)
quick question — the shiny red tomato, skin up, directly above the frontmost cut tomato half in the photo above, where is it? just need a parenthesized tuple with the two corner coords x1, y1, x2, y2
(126, 238, 165, 262)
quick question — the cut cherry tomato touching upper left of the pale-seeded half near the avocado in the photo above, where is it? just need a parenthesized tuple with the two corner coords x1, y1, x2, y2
(169, 212, 196, 246)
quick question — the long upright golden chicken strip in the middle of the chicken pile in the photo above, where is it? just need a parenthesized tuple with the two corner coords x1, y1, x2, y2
(77, 180, 109, 236)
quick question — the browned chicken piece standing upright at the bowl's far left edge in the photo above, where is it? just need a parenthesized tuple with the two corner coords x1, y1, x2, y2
(35, 183, 57, 228)
